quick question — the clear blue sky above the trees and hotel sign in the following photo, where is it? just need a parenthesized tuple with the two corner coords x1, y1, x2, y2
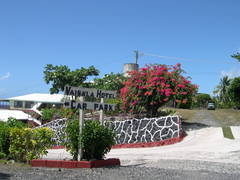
(0, 0, 240, 98)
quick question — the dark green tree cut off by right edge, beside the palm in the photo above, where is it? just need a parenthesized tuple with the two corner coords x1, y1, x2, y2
(228, 77, 240, 108)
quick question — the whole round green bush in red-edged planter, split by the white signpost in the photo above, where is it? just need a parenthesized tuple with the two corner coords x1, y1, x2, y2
(64, 120, 115, 160)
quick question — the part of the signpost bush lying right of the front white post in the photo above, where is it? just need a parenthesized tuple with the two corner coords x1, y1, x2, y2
(80, 121, 115, 160)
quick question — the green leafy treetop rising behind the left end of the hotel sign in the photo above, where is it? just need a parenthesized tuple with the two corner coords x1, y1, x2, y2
(43, 64, 99, 94)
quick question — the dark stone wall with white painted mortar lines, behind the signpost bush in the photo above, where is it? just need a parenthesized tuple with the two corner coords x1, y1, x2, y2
(37, 116, 181, 145)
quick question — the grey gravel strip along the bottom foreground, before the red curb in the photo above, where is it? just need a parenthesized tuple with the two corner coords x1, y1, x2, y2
(0, 160, 240, 180)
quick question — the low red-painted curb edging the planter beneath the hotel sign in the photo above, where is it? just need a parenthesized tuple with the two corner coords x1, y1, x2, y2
(31, 159, 120, 168)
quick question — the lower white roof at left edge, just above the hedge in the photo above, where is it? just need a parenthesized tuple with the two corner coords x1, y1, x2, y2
(0, 109, 30, 122)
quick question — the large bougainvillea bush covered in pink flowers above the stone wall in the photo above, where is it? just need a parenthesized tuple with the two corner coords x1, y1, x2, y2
(121, 64, 198, 116)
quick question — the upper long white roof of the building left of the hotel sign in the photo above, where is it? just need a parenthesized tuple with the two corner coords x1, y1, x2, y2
(8, 93, 64, 103)
